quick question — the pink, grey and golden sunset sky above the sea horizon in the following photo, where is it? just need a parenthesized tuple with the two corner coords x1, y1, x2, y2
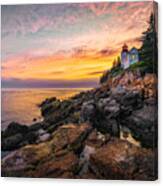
(1, 1, 152, 87)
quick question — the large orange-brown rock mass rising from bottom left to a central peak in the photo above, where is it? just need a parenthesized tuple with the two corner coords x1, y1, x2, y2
(2, 123, 92, 178)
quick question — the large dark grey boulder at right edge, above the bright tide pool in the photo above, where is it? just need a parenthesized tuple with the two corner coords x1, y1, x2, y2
(121, 105, 157, 148)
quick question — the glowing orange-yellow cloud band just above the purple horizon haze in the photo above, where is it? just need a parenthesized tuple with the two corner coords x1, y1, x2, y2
(2, 45, 115, 80)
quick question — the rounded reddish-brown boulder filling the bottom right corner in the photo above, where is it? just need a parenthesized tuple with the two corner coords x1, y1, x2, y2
(90, 139, 157, 180)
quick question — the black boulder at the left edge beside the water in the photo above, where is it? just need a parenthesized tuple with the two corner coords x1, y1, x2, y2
(1, 122, 50, 151)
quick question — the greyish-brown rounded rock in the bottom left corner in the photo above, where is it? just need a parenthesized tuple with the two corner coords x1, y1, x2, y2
(2, 143, 52, 177)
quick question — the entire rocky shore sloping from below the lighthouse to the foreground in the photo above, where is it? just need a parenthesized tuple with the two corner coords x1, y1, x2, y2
(2, 69, 157, 180)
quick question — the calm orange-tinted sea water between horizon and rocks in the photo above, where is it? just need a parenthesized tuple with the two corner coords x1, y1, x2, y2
(1, 89, 86, 130)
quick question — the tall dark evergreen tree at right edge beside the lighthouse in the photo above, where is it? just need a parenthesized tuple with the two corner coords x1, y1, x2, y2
(140, 14, 158, 73)
